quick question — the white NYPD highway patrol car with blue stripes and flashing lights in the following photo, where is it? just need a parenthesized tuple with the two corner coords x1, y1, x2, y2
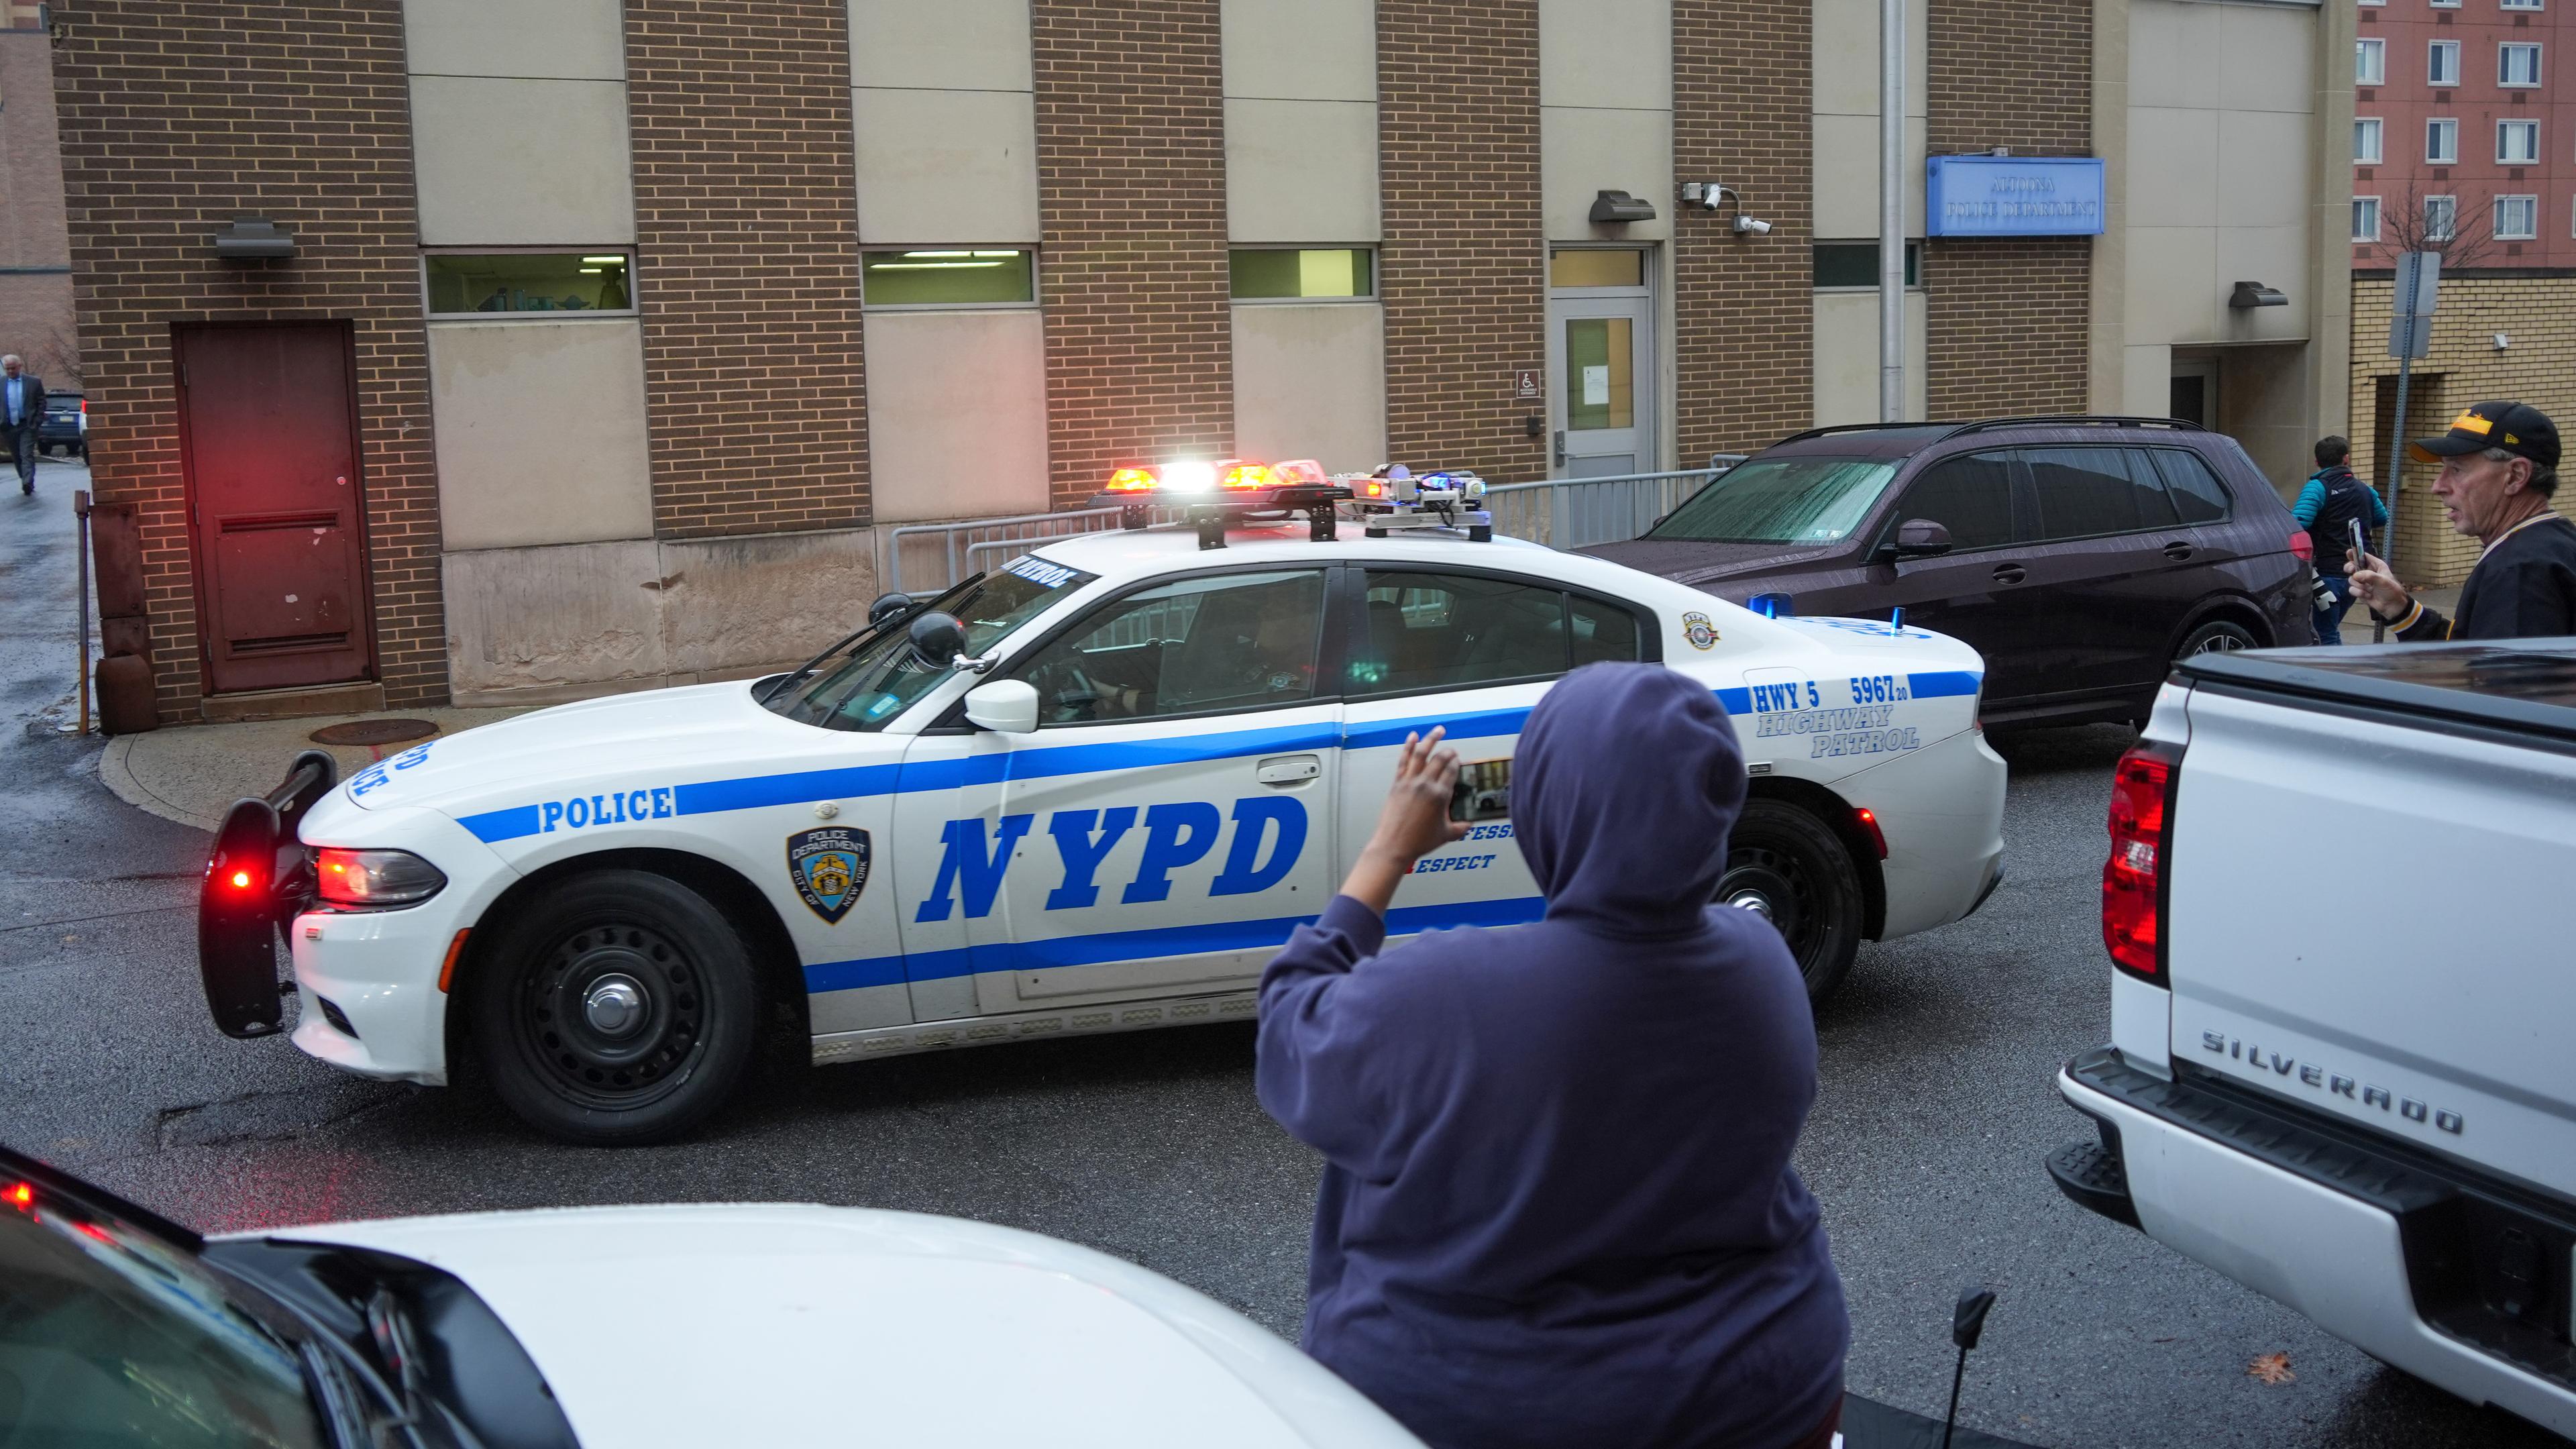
(199, 464, 2004, 1142)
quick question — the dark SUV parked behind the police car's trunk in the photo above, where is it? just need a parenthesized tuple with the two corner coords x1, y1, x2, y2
(1582, 418, 2316, 724)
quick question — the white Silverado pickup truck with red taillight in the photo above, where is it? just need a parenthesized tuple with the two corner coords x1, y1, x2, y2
(2048, 639, 2576, 1436)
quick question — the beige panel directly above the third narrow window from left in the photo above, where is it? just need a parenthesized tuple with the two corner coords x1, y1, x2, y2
(1226, 101, 1378, 245)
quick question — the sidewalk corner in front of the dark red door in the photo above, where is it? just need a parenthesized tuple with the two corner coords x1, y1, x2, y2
(98, 709, 523, 830)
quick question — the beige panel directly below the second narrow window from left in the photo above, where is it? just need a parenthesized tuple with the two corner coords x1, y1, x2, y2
(868, 309, 1046, 523)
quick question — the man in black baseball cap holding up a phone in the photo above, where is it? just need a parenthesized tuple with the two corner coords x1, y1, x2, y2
(2347, 402, 2576, 645)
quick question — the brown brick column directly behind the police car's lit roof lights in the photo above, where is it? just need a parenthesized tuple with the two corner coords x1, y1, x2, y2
(1030, 0, 1234, 508)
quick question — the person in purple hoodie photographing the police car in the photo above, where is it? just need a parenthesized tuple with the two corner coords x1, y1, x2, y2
(1254, 663, 1849, 1449)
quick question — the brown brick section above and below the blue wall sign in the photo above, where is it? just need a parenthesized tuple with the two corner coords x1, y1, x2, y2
(1924, 0, 2092, 418)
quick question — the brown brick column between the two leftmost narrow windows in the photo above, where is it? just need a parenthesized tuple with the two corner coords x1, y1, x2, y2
(626, 0, 868, 539)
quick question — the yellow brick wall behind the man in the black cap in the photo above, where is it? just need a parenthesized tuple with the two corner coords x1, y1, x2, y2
(2352, 273, 2576, 588)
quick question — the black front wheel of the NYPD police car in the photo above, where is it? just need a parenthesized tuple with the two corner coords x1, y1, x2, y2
(472, 871, 760, 1144)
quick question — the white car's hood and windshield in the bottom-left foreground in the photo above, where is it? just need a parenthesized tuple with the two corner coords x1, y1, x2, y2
(0, 1150, 1422, 1449)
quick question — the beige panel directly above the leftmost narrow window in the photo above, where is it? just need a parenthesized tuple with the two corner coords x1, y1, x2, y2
(412, 74, 652, 245)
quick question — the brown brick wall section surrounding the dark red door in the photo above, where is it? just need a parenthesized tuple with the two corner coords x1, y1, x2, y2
(54, 0, 448, 719)
